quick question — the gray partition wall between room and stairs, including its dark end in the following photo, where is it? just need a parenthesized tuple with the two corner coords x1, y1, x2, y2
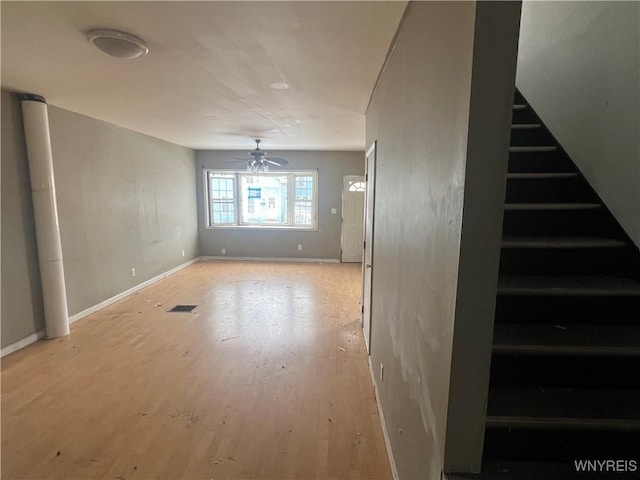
(367, 2, 519, 480)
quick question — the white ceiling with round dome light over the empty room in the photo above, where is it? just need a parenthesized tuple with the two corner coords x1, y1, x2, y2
(0, 1, 406, 150)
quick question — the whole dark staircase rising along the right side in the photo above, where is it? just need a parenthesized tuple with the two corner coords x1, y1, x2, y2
(449, 92, 640, 480)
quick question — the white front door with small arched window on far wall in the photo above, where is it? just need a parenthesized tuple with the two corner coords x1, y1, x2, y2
(341, 175, 365, 262)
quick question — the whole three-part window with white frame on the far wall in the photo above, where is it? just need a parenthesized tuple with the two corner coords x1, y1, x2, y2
(204, 170, 318, 230)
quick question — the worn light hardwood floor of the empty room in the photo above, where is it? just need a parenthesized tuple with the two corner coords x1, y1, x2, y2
(1, 262, 391, 480)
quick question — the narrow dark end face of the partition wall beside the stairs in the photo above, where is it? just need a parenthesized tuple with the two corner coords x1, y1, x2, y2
(445, 1, 521, 472)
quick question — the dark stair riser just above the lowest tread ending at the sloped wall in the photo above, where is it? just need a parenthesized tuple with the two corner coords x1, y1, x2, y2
(503, 209, 619, 238)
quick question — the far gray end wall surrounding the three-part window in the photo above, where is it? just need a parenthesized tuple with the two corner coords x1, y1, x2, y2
(195, 150, 364, 260)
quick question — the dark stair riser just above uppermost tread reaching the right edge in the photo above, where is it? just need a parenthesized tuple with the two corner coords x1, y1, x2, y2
(500, 248, 633, 276)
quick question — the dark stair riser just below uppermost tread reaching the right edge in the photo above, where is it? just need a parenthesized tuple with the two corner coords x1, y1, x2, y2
(495, 295, 640, 325)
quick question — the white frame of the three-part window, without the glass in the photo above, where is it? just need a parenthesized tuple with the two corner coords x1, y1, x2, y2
(203, 168, 319, 232)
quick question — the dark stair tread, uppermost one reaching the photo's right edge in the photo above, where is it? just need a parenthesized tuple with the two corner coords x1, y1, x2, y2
(498, 276, 640, 296)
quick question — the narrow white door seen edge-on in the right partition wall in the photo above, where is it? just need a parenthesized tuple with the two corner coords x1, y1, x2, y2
(362, 142, 376, 353)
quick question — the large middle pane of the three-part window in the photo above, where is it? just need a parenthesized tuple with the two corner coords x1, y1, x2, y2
(239, 174, 289, 225)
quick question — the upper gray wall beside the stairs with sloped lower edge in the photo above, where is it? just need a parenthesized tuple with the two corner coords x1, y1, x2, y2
(516, 1, 640, 245)
